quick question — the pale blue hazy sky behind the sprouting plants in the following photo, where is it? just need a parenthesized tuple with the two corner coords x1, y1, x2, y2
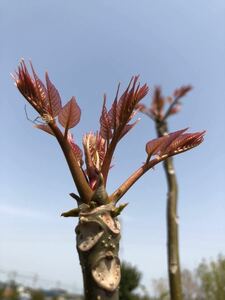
(0, 0, 225, 291)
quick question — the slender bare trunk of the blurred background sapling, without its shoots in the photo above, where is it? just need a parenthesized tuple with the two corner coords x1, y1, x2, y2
(156, 122, 183, 300)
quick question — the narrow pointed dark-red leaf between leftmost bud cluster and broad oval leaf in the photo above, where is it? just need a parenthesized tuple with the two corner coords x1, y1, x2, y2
(45, 72, 62, 118)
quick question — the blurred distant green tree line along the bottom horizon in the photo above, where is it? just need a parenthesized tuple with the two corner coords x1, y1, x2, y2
(0, 255, 225, 300)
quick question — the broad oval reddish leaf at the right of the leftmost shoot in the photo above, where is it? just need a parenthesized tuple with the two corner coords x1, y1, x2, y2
(58, 97, 81, 129)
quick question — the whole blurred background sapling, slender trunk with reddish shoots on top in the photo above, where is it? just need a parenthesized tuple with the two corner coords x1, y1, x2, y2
(139, 86, 194, 300)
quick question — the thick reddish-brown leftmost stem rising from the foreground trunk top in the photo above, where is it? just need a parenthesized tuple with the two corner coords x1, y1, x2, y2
(48, 123, 93, 203)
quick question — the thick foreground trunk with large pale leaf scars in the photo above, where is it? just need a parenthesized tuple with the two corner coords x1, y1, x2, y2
(75, 207, 121, 300)
